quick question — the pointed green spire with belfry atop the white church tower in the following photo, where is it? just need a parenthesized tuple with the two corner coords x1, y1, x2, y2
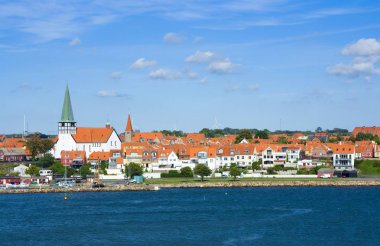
(58, 85, 77, 134)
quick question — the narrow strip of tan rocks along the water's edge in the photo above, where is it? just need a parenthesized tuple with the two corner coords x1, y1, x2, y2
(0, 180, 380, 195)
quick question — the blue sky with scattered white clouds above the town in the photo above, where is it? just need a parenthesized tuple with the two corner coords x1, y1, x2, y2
(0, 0, 380, 134)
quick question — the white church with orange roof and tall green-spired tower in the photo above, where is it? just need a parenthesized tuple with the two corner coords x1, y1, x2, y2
(52, 85, 121, 159)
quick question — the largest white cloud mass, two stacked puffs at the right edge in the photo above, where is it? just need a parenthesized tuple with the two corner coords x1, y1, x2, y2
(326, 38, 380, 80)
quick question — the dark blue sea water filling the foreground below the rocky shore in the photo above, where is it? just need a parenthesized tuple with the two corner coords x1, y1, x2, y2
(0, 187, 380, 245)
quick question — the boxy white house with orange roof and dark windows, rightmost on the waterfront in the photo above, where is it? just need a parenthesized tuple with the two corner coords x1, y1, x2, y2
(330, 142, 355, 170)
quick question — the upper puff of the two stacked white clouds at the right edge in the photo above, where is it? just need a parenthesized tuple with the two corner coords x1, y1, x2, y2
(342, 38, 380, 56)
